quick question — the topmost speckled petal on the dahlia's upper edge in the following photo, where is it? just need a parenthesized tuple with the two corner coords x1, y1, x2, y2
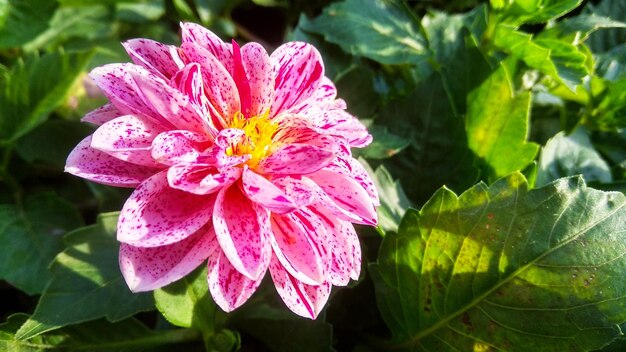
(180, 23, 233, 72)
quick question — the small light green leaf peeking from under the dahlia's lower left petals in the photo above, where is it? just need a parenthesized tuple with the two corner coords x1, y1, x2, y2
(154, 265, 218, 333)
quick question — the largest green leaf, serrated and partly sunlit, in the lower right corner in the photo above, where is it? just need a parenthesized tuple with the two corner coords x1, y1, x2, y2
(370, 174, 626, 351)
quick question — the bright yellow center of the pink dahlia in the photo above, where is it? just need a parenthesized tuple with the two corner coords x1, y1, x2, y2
(226, 110, 278, 168)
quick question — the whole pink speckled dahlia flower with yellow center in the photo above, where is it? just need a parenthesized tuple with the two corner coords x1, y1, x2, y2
(66, 23, 378, 318)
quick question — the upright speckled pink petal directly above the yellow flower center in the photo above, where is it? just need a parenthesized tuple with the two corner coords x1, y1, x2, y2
(241, 43, 274, 116)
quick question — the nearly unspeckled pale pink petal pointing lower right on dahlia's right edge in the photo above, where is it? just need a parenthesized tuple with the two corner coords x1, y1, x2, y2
(307, 170, 377, 225)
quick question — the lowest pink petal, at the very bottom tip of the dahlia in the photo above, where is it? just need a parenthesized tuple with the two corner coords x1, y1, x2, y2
(270, 258, 331, 319)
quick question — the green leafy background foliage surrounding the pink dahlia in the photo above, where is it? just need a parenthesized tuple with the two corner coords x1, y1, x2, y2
(0, 0, 626, 351)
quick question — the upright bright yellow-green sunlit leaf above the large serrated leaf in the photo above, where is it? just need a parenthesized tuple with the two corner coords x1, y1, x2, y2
(466, 65, 539, 181)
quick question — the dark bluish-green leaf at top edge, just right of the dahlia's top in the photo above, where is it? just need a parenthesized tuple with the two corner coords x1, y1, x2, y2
(303, 0, 430, 64)
